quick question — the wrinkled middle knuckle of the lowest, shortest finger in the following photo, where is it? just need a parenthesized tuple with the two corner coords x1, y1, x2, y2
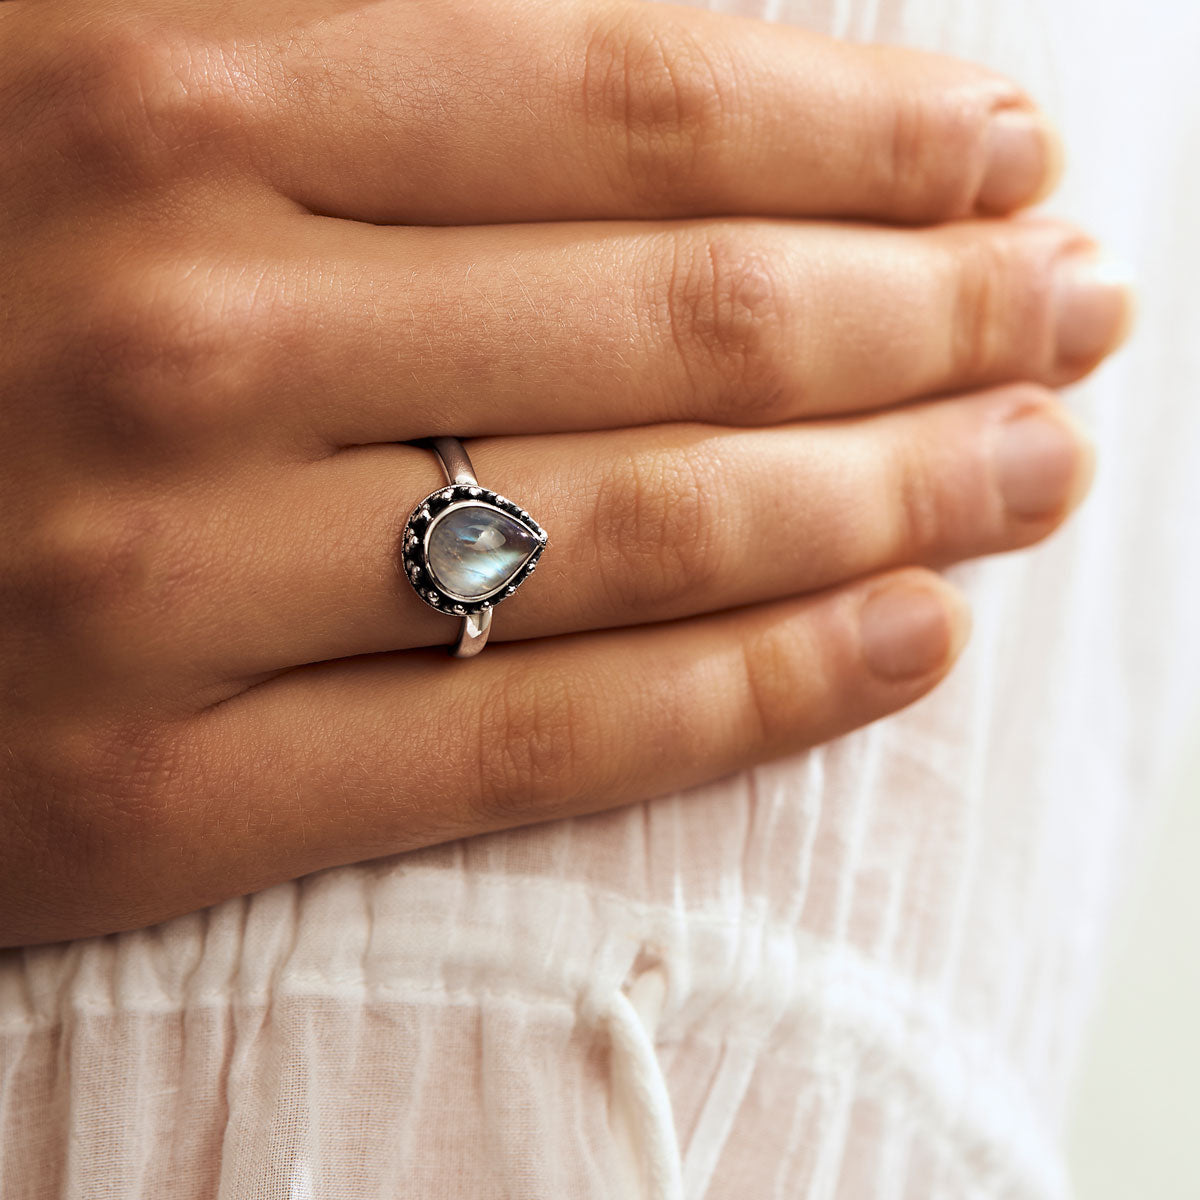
(475, 666, 596, 828)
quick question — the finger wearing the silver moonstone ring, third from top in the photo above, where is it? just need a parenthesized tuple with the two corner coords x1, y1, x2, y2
(100, 385, 1090, 680)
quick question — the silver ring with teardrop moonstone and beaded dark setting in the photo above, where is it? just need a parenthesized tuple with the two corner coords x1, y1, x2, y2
(402, 438, 547, 659)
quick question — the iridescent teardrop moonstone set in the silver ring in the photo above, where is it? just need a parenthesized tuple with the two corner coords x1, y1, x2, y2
(427, 504, 541, 600)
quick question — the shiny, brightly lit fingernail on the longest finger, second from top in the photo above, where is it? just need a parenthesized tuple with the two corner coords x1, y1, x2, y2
(1055, 251, 1133, 367)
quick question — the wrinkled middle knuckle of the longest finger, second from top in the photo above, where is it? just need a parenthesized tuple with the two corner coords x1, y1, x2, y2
(652, 232, 787, 425)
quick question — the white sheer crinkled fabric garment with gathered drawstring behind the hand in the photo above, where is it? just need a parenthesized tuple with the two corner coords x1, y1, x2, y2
(0, 0, 1200, 1200)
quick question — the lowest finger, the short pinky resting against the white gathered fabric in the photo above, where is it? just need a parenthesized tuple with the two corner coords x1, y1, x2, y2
(145, 568, 968, 916)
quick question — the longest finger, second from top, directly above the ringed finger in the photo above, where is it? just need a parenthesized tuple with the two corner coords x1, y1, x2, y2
(164, 218, 1128, 456)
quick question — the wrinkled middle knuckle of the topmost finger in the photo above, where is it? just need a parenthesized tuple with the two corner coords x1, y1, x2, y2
(582, 12, 739, 210)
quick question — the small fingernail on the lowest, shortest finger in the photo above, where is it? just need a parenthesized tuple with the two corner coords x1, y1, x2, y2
(860, 583, 954, 680)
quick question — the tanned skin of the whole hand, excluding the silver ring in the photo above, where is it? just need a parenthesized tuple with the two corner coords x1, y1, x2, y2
(0, 0, 1128, 946)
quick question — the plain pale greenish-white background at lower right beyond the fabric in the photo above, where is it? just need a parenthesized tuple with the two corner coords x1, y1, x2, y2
(1068, 722, 1200, 1200)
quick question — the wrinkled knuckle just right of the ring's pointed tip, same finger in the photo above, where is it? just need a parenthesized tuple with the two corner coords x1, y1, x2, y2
(593, 446, 725, 619)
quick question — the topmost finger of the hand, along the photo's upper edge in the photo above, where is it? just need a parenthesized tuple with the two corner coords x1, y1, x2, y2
(25, 0, 1058, 224)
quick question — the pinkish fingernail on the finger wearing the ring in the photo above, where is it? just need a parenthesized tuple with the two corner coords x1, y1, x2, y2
(992, 409, 1082, 517)
